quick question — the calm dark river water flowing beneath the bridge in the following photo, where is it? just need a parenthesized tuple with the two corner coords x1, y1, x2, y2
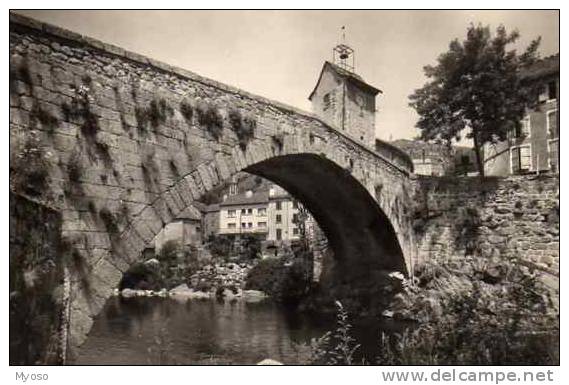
(73, 297, 404, 365)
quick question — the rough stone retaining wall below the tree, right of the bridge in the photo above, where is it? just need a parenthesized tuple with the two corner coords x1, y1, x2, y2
(414, 175, 559, 276)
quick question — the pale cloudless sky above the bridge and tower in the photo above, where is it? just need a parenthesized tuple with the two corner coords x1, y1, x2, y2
(14, 10, 559, 140)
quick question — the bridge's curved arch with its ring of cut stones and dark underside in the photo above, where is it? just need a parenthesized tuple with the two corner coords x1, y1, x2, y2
(70, 135, 408, 346)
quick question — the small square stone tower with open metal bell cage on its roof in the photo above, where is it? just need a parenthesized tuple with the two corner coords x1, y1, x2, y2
(308, 36, 381, 148)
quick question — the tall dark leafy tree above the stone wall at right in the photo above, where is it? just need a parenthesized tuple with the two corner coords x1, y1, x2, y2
(409, 24, 541, 176)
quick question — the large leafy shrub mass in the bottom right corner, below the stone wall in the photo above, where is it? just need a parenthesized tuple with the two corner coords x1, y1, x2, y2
(380, 258, 559, 365)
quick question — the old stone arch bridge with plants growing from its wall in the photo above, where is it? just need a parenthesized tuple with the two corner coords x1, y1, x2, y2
(10, 15, 415, 347)
